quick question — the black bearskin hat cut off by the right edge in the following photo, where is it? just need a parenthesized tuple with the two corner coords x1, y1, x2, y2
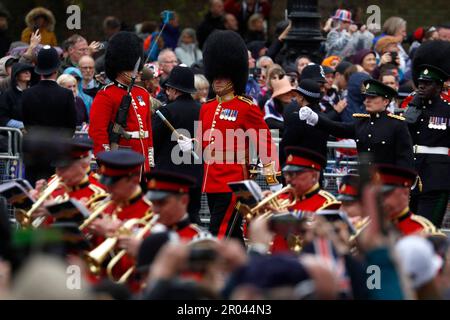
(412, 40, 450, 86)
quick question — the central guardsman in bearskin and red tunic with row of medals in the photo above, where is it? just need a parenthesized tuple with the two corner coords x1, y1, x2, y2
(186, 31, 281, 239)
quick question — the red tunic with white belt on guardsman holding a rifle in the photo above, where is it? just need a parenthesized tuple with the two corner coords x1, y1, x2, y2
(89, 82, 153, 172)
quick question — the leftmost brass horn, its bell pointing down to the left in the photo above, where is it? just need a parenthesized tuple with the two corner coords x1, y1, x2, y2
(16, 176, 62, 228)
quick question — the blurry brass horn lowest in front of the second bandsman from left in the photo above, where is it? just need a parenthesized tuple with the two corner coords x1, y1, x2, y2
(85, 218, 154, 275)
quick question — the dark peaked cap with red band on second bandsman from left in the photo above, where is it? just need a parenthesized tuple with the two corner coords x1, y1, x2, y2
(97, 150, 145, 186)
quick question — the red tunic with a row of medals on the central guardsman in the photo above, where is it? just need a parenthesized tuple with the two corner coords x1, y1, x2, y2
(197, 96, 278, 193)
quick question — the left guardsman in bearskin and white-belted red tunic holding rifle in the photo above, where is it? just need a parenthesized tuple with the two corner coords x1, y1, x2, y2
(89, 32, 153, 172)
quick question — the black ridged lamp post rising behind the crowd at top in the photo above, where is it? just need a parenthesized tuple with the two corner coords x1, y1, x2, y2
(285, 0, 325, 64)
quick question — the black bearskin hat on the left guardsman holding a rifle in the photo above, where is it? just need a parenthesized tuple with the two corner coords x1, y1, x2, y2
(105, 31, 144, 80)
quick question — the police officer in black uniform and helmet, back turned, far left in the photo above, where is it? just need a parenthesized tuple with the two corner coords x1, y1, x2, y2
(22, 46, 76, 144)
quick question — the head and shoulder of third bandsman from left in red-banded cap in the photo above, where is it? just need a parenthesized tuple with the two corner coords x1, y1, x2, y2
(146, 170, 204, 242)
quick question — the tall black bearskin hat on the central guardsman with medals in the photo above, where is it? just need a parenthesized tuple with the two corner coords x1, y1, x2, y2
(203, 30, 248, 95)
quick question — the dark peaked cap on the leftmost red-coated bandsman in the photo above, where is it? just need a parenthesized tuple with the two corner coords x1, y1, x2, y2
(51, 137, 92, 168)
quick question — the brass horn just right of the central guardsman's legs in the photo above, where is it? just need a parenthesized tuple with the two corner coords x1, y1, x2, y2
(237, 185, 297, 221)
